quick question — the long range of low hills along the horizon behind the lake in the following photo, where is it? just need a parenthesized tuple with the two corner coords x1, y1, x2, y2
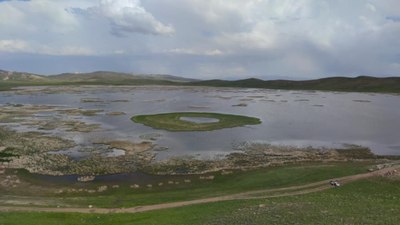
(0, 70, 400, 93)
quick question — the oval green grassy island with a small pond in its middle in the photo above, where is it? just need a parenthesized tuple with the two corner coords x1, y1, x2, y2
(132, 112, 261, 131)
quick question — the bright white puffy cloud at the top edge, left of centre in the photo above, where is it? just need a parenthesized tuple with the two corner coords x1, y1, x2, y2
(87, 0, 175, 36)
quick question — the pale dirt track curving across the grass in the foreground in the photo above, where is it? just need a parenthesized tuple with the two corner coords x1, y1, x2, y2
(0, 165, 400, 213)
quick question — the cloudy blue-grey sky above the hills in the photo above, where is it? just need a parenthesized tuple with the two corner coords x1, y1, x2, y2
(0, 0, 400, 79)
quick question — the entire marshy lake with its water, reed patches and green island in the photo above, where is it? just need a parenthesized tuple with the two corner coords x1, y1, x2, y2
(0, 86, 400, 180)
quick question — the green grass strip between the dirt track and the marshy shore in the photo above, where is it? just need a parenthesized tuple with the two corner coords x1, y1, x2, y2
(4, 163, 370, 208)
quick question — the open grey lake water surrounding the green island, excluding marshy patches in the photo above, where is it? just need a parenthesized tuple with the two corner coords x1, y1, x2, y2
(0, 86, 400, 159)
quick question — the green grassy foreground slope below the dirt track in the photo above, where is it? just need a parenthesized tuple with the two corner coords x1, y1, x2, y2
(0, 178, 400, 225)
